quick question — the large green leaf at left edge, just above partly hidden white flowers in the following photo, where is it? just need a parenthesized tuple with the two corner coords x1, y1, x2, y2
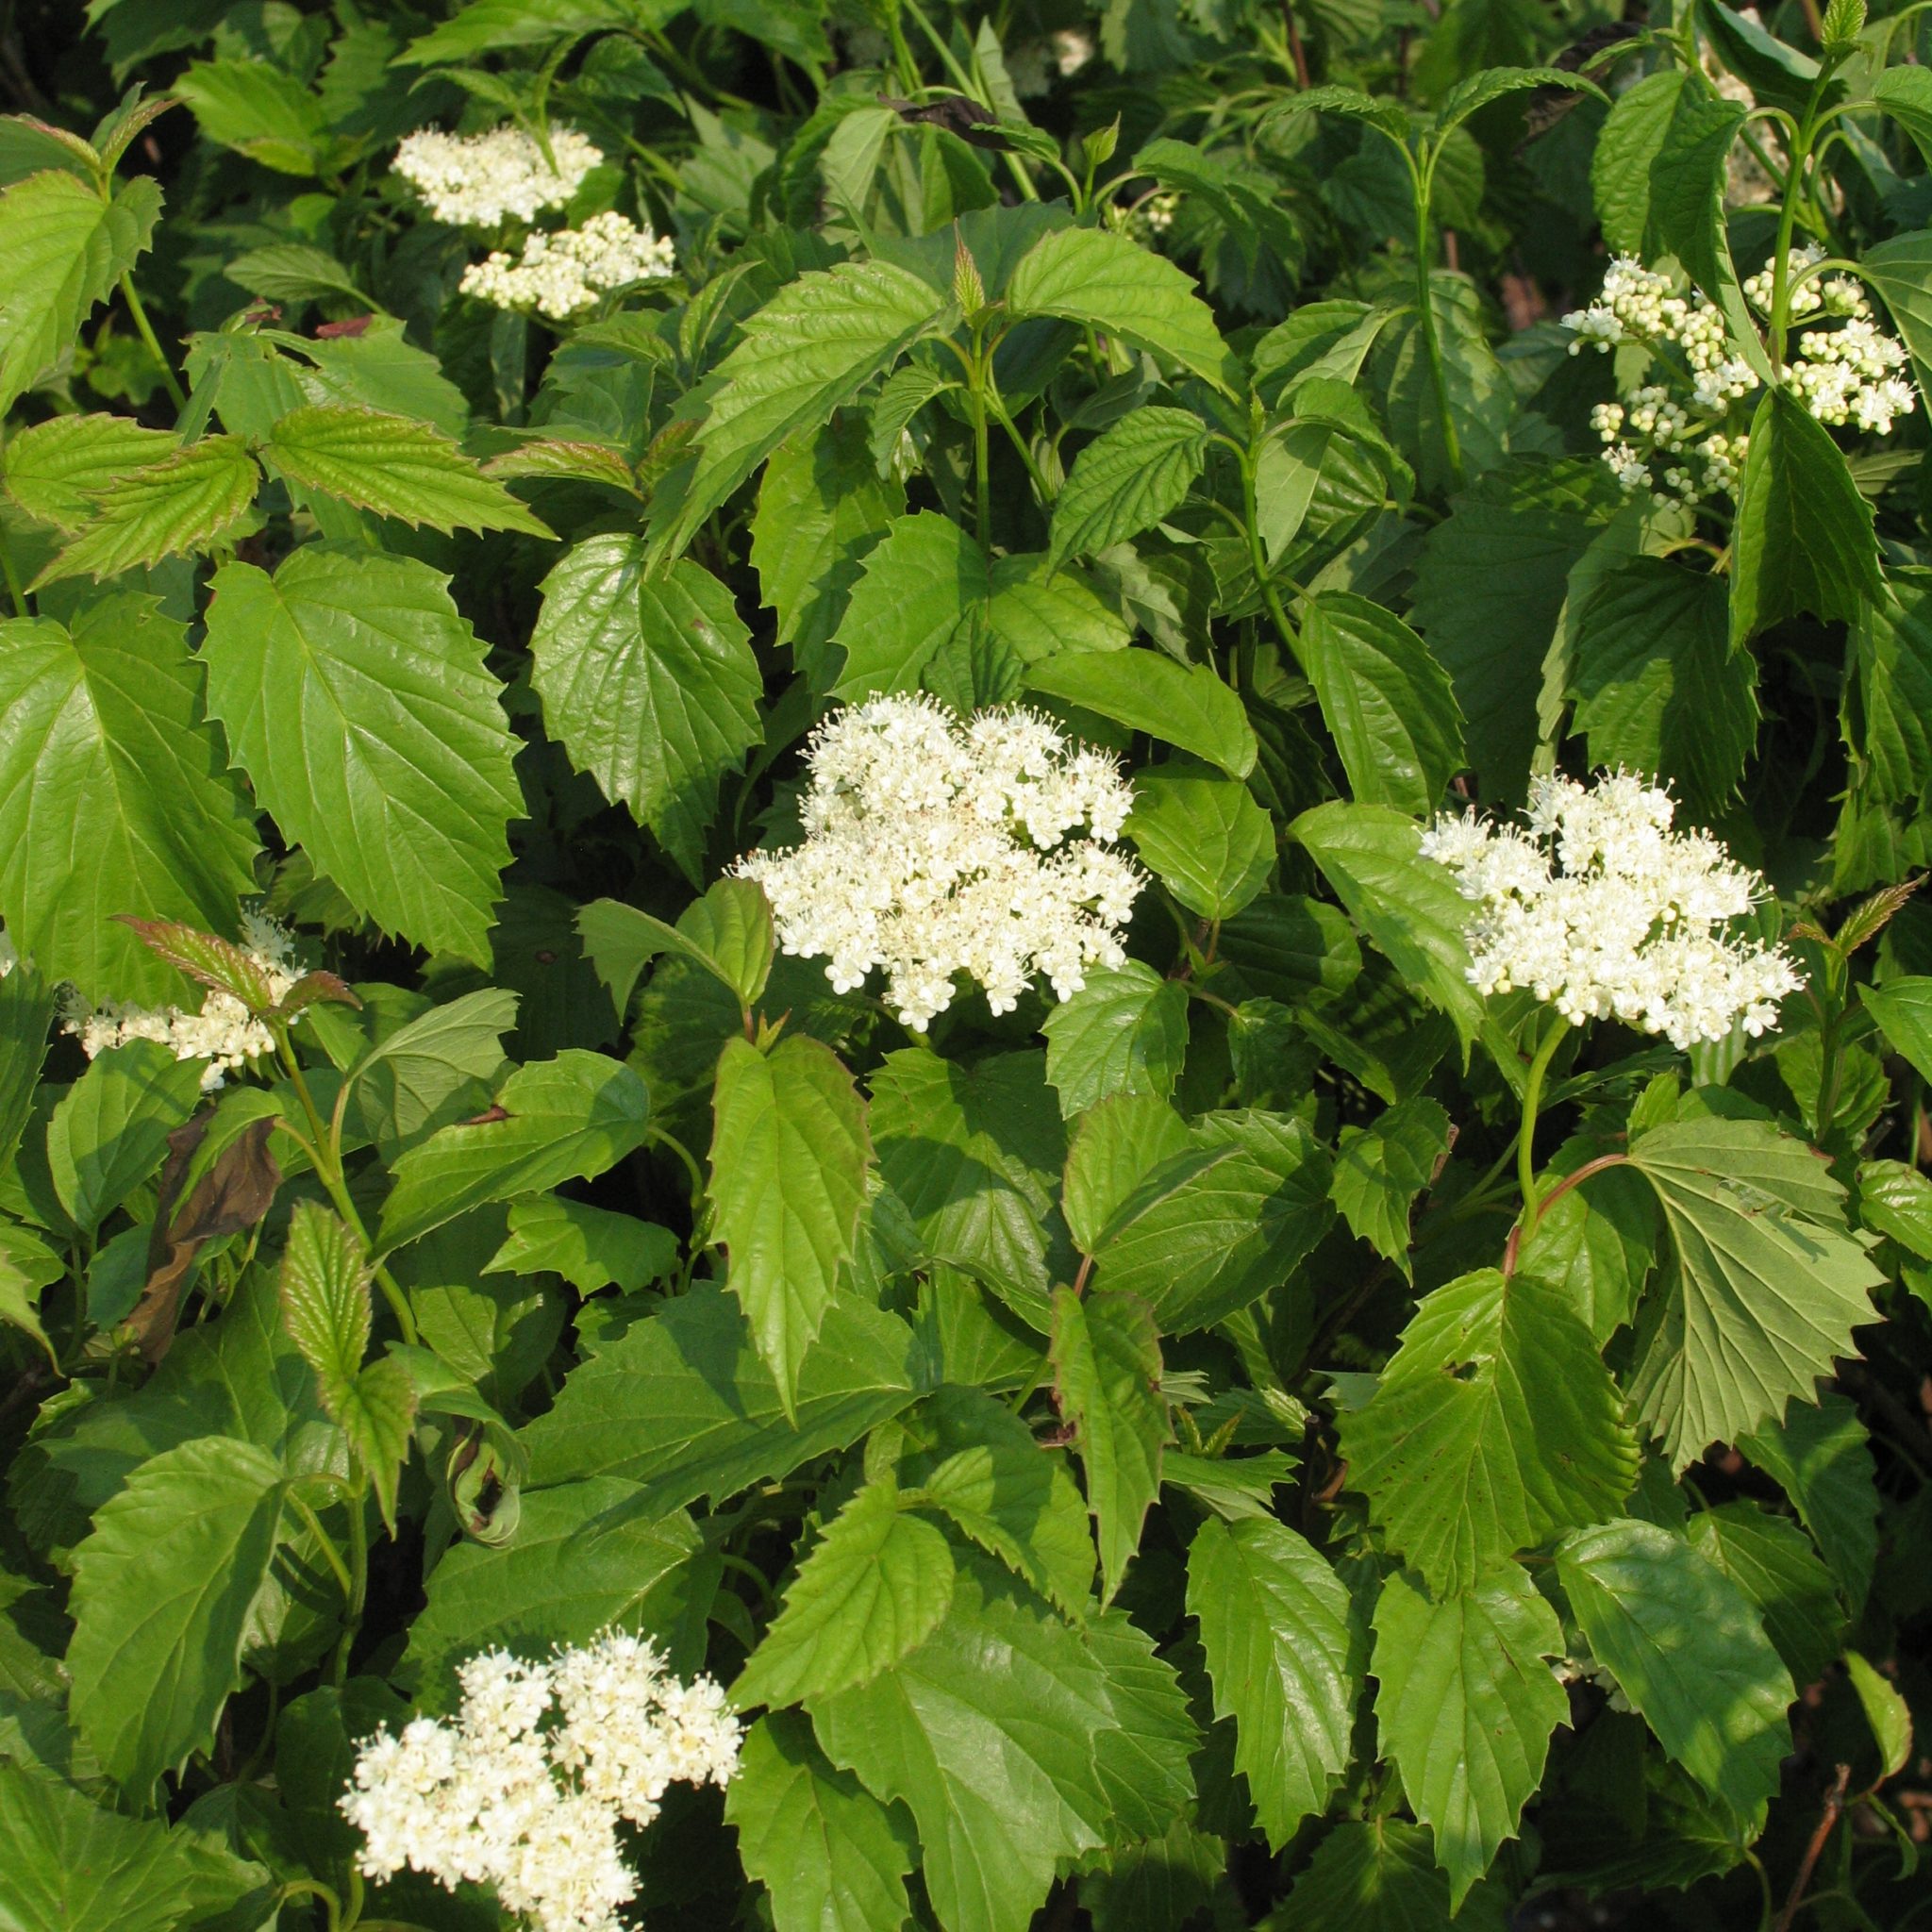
(0, 597, 257, 1001)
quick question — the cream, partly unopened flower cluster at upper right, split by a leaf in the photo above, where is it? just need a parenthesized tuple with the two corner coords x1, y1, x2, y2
(1563, 247, 1917, 505)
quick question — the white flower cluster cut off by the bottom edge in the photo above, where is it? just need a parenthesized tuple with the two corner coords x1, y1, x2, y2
(341, 1631, 740, 1932)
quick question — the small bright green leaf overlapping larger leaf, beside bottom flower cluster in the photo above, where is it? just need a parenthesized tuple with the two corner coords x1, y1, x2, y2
(732, 1480, 953, 1709)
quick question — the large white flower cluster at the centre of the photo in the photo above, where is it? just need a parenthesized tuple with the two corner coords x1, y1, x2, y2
(734, 695, 1143, 1032)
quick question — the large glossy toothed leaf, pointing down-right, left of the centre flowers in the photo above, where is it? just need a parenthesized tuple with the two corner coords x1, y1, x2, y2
(203, 545, 524, 966)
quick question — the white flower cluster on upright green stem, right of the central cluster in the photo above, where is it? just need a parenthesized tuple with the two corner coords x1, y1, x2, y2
(1422, 771, 1805, 1047)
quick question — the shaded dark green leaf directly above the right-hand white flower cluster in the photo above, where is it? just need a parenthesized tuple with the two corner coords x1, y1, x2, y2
(1574, 557, 1760, 811)
